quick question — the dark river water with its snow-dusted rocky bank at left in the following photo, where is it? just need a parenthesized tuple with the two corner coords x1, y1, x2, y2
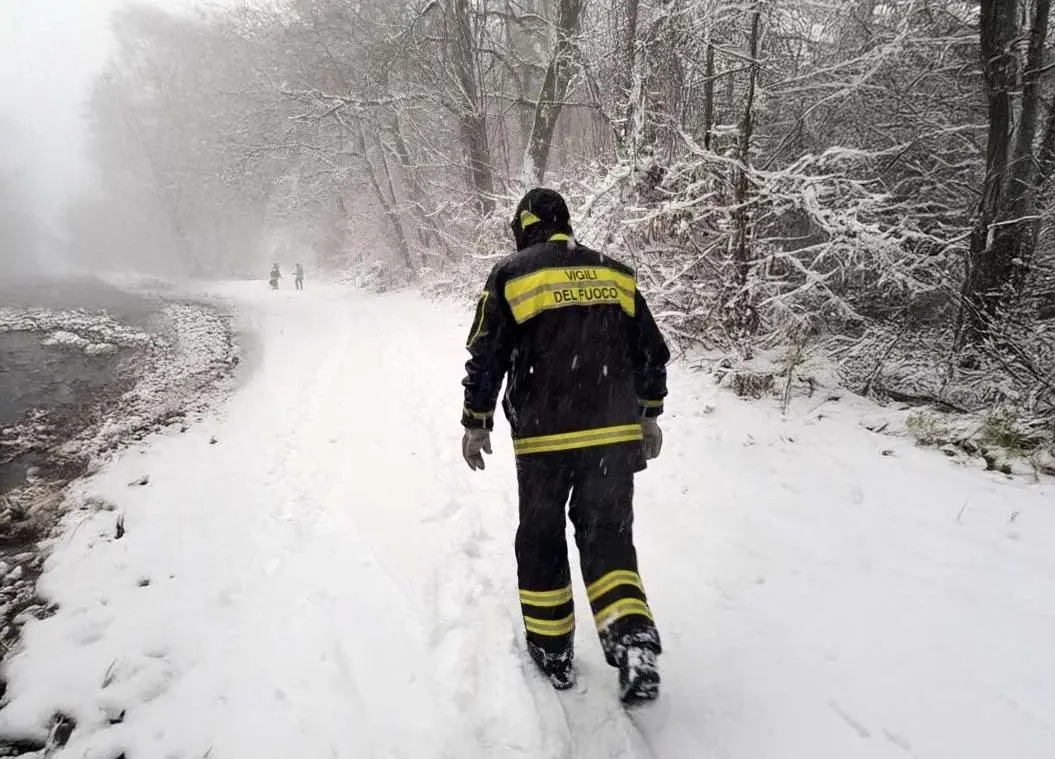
(0, 281, 238, 667)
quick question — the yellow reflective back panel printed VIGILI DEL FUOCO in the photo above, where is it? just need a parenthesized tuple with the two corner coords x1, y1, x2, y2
(503, 266, 637, 324)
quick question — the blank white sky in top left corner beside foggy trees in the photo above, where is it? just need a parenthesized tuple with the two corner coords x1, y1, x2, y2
(0, 0, 219, 229)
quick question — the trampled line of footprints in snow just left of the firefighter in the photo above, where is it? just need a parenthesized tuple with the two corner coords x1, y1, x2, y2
(350, 299, 551, 757)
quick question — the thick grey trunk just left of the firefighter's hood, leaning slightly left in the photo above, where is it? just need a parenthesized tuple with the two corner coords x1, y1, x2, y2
(450, 0, 495, 213)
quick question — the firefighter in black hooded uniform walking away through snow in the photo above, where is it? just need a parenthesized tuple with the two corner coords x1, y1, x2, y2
(462, 188, 670, 702)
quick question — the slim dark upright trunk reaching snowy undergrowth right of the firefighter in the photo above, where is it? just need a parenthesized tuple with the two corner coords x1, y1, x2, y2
(731, 0, 762, 338)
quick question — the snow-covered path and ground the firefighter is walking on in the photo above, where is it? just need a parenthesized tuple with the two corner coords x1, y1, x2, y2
(0, 283, 1055, 759)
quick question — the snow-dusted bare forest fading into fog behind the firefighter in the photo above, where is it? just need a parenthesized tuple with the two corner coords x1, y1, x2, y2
(68, 0, 1055, 467)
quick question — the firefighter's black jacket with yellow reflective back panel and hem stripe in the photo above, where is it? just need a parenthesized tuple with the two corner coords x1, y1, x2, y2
(462, 234, 670, 469)
